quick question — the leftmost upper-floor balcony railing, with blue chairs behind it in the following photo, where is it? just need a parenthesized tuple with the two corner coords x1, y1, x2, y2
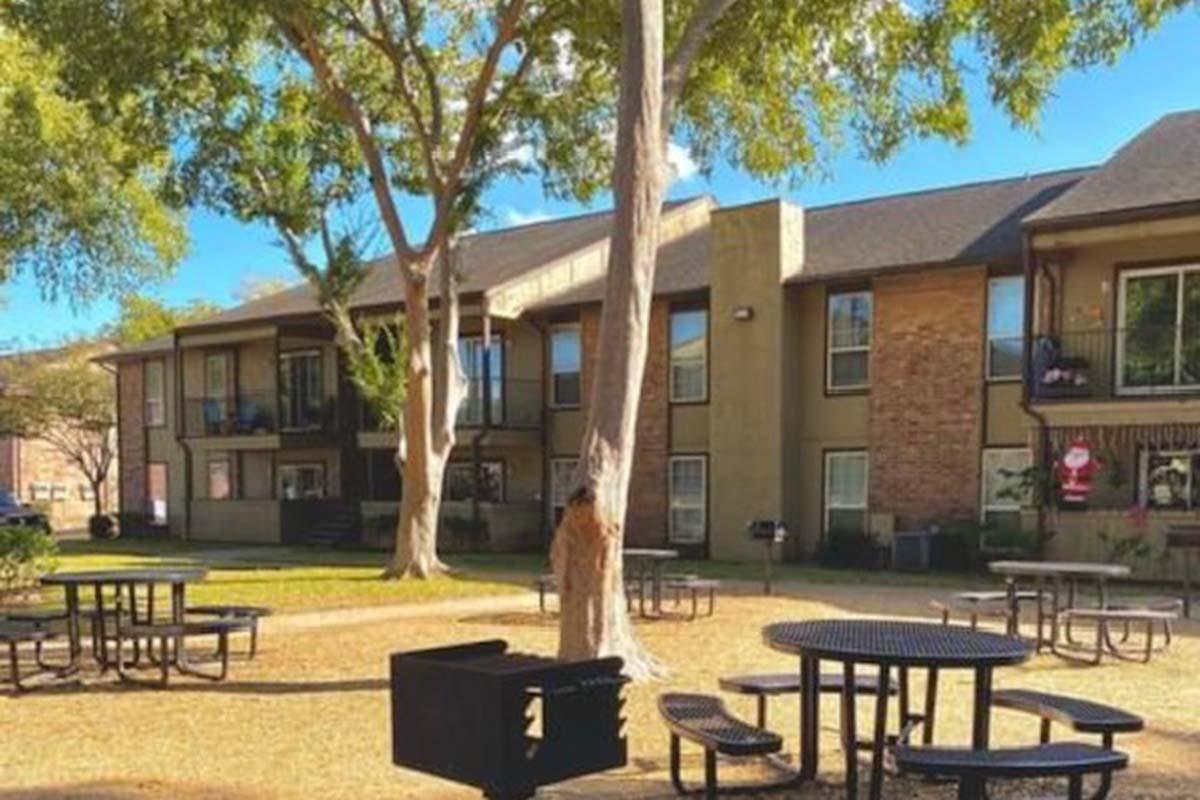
(184, 392, 337, 437)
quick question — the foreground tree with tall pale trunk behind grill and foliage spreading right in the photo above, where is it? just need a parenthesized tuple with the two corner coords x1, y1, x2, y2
(552, 0, 1188, 676)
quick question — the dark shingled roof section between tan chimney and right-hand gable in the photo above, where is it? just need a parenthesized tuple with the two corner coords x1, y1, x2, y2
(790, 168, 1091, 283)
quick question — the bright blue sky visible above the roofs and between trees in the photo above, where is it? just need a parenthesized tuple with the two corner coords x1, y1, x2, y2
(0, 10, 1200, 349)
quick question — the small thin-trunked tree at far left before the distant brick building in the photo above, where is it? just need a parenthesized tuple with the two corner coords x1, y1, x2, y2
(0, 342, 116, 525)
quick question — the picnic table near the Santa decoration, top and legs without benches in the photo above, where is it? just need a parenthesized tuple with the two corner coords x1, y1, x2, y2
(988, 560, 1130, 652)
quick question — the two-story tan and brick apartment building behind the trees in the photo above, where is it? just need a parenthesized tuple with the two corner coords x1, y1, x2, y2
(103, 113, 1200, 575)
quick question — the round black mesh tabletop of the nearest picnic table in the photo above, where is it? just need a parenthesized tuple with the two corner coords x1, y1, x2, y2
(763, 619, 1030, 668)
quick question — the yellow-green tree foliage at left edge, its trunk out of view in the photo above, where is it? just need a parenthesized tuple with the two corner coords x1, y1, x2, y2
(0, 23, 185, 303)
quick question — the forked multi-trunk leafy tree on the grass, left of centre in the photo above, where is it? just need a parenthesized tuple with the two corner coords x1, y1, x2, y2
(11, 0, 611, 576)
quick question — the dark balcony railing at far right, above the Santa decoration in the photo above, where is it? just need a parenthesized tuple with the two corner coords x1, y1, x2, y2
(1028, 325, 1200, 399)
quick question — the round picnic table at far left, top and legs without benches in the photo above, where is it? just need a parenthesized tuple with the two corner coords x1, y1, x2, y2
(42, 567, 208, 672)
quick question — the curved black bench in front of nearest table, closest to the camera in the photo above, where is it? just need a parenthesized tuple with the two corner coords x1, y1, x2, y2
(894, 741, 1129, 800)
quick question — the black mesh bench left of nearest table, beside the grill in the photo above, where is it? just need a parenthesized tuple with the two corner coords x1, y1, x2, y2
(659, 693, 794, 799)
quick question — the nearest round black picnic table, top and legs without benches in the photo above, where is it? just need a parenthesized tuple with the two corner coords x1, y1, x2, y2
(762, 619, 1030, 800)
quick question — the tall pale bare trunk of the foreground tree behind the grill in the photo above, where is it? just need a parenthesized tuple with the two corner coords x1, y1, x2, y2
(551, 0, 665, 678)
